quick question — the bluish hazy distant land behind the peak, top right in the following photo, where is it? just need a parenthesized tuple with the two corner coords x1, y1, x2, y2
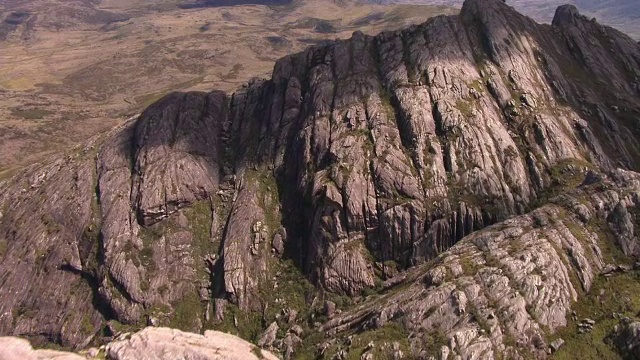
(377, 0, 640, 40)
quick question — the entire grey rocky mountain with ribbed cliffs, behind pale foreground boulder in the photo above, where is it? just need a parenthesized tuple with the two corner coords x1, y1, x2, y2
(0, 0, 640, 359)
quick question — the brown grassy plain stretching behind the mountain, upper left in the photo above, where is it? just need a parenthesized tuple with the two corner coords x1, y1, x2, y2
(0, 0, 457, 178)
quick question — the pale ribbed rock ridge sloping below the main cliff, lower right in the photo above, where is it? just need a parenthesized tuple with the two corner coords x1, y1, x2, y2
(323, 171, 640, 359)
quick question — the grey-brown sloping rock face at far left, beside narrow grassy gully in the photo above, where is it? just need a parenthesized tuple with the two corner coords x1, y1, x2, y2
(0, 145, 103, 346)
